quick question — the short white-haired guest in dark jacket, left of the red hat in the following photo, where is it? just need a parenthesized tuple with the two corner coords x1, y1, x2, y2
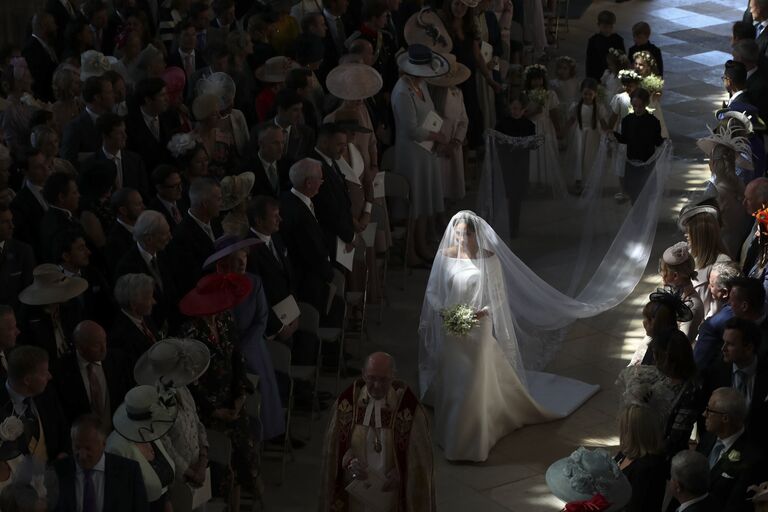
(109, 274, 160, 364)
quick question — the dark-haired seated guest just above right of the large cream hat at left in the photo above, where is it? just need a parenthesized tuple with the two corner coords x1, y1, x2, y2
(52, 230, 115, 327)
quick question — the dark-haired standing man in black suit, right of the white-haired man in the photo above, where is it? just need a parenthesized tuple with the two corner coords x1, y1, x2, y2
(311, 124, 356, 260)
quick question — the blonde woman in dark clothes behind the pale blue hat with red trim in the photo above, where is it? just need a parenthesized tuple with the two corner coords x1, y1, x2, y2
(616, 400, 667, 512)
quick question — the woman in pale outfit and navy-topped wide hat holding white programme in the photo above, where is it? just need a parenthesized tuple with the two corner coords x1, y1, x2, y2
(392, 44, 449, 267)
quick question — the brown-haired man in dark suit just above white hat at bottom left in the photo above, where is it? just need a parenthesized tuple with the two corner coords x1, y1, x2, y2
(0, 347, 70, 464)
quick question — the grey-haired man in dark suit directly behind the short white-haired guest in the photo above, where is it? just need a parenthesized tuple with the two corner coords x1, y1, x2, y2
(115, 210, 179, 331)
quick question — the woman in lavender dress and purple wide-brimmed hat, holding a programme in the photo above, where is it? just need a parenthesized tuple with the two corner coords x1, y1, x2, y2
(205, 235, 288, 439)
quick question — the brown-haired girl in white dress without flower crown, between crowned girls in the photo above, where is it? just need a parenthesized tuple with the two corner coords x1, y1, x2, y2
(566, 78, 608, 195)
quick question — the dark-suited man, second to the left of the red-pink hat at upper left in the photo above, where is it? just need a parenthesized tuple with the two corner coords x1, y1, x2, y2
(59, 76, 115, 166)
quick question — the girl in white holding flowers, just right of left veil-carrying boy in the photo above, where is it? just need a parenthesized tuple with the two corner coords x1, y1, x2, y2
(525, 64, 565, 195)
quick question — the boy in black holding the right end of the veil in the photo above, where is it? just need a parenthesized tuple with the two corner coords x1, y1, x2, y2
(613, 89, 664, 204)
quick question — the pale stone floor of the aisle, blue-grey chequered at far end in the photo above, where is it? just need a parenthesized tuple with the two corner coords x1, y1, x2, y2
(264, 0, 745, 512)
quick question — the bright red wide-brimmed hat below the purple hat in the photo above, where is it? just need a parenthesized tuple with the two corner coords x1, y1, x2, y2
(179, 273, 253, 316)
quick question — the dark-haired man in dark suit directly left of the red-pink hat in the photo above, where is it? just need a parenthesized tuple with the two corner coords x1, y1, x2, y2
(125, 78, 179, 169)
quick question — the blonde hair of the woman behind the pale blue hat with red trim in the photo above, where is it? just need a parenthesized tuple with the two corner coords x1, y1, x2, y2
(619, 404, 664, 459)
